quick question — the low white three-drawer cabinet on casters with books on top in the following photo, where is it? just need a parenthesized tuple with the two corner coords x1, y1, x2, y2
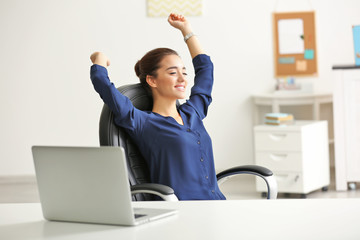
(254, 121, 330, 194)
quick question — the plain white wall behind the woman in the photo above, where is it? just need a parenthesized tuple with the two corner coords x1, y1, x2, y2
(0, 0, 360, 176)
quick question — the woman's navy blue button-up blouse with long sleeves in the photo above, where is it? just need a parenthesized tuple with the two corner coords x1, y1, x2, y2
(90, 54, 225, 200)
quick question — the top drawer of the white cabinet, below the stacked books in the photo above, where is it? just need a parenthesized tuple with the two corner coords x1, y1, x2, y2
(255, 132, 301, 151)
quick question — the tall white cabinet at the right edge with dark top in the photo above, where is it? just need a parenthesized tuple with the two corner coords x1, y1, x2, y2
(333, 66, 360, 190)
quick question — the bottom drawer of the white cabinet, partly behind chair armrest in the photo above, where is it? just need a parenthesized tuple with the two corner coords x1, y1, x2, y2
(256, 172, 305, 193)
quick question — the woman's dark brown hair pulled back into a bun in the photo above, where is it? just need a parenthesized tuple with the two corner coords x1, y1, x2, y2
(135, 48, 179, 94)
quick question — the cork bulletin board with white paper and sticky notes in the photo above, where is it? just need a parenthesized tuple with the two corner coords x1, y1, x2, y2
(273, 11, 317, 77)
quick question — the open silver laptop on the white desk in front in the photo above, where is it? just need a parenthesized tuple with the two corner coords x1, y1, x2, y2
(32, 146, 176, 226)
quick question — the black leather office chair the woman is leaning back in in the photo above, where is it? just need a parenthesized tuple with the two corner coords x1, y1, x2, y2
(99, 83, 277, 201)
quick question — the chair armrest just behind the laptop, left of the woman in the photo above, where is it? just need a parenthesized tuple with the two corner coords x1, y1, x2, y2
(131, 183, 179, 201)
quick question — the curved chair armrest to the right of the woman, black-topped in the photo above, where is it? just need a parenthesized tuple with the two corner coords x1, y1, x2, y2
(216, 165, 277, 199)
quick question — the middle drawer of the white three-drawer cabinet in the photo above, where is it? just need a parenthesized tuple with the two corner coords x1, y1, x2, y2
(255, 152, 302, 172)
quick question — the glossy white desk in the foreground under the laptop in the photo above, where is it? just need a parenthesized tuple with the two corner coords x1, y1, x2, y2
(0, 199, 360, 240)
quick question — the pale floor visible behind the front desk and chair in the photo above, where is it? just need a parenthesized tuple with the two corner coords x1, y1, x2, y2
(0, 168, 360, 203)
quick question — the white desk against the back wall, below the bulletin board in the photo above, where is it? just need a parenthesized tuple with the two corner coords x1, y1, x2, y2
(253, 92, 332, 125)
